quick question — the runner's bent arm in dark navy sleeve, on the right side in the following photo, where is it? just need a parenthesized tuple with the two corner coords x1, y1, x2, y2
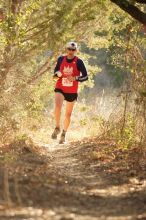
(76, 59, 88, 82)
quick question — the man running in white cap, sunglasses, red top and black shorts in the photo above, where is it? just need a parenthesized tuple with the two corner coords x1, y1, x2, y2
(52, 42, 88, 144)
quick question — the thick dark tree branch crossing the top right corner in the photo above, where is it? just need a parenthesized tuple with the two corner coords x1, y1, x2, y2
(111, 0, 146, 24)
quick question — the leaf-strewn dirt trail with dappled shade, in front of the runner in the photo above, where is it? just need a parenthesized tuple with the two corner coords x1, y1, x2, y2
(0, 140, 146, 220)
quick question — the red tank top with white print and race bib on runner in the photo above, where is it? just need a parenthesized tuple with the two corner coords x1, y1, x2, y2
(55, 56, 80, 93)
